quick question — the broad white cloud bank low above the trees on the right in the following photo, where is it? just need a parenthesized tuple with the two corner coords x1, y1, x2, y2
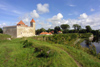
(47, 13, 100, 29)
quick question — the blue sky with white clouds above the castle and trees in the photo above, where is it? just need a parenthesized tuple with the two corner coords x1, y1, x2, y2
(0, 0, 100, 29)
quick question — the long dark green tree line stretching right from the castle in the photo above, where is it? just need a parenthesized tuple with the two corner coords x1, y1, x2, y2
(36, 24, 99, 35)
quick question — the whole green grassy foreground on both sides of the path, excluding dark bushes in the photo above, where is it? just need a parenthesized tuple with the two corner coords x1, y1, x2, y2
(0, 33, 100, 67)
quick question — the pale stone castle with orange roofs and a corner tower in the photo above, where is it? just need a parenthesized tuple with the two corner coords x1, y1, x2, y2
(3, 19, 35, 38)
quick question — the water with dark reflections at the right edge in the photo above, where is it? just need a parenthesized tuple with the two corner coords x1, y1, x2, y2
(80, 37, 100, 53)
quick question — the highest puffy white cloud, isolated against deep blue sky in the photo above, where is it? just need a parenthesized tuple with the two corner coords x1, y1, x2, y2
(37, 3, 49, 14)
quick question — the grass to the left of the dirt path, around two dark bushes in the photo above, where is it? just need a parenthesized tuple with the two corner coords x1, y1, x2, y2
(0, 39, 77, 67)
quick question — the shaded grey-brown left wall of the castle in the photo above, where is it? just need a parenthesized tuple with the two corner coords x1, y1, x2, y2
(3, 26, 17, 37)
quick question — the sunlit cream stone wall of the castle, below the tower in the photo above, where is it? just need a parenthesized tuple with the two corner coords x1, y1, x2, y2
(17, 26, 35, 38)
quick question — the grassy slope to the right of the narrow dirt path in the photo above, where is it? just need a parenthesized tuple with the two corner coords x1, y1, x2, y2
(28, 38, 100, 67)
